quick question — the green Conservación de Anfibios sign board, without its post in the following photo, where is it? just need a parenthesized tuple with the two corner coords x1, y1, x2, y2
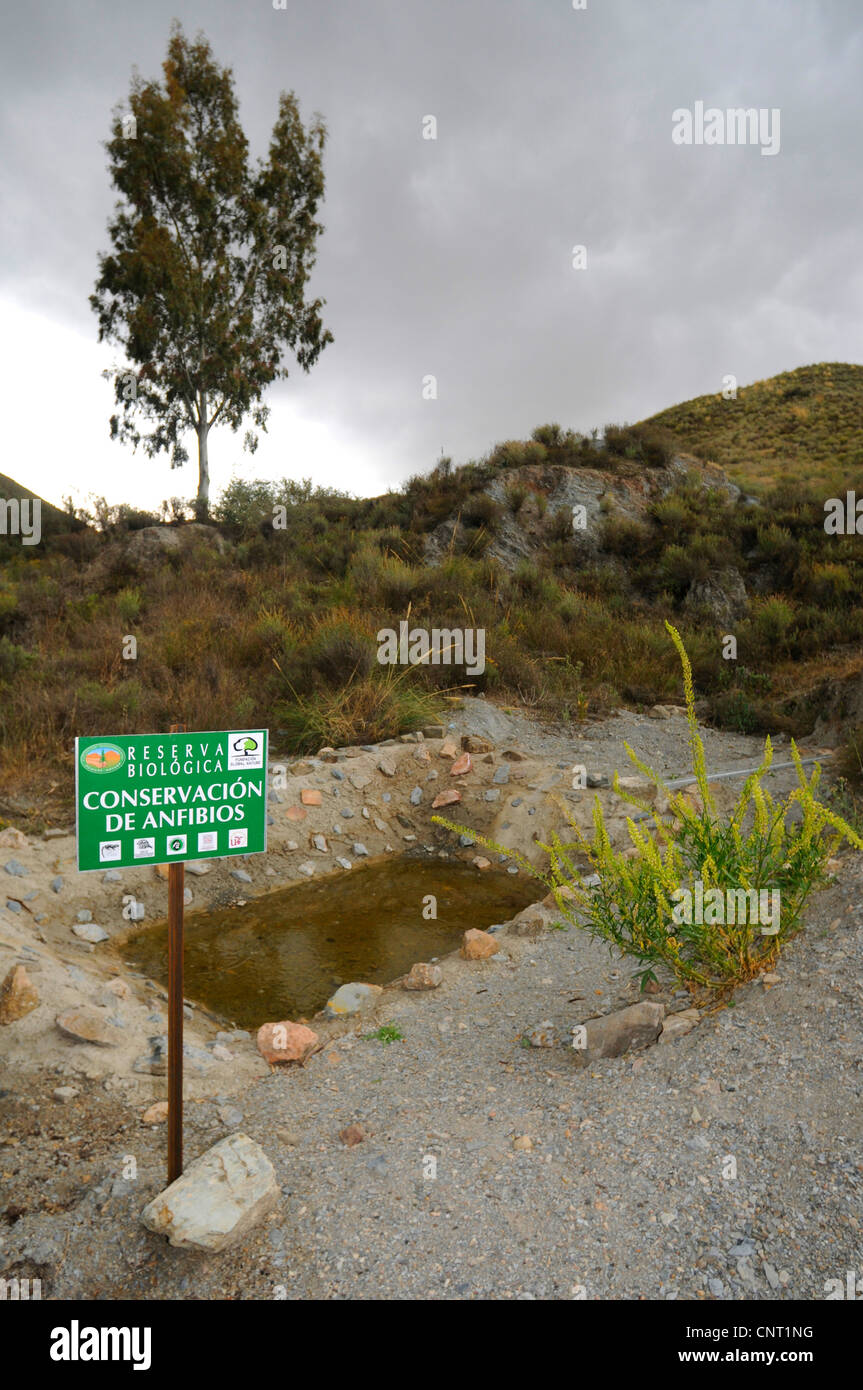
(75, 728, 267, 873)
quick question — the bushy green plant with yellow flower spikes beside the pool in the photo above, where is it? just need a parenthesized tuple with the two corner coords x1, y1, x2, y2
(434, 623, 863, 998)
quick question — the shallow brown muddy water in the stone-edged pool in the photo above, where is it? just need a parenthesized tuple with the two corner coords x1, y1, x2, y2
(122, 860, 545, 1029)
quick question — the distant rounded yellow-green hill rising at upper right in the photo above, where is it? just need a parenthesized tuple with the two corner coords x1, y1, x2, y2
(645, 361, 863, 496)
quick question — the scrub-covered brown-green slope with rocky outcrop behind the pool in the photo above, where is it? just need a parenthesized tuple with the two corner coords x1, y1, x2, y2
(0, 367, 863, 815)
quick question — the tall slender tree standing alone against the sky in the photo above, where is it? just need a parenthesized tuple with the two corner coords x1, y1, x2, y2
(90, 24, 332, 518)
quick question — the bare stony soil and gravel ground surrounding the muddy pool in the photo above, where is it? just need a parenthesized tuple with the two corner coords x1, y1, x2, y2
(0, 701, 863, 1298)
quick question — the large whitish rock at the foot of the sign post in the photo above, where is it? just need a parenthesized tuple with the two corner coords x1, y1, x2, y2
(140, 1133, 279, 1251)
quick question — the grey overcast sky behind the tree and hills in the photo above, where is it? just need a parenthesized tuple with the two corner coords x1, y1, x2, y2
(0, 0, 863, 506)
